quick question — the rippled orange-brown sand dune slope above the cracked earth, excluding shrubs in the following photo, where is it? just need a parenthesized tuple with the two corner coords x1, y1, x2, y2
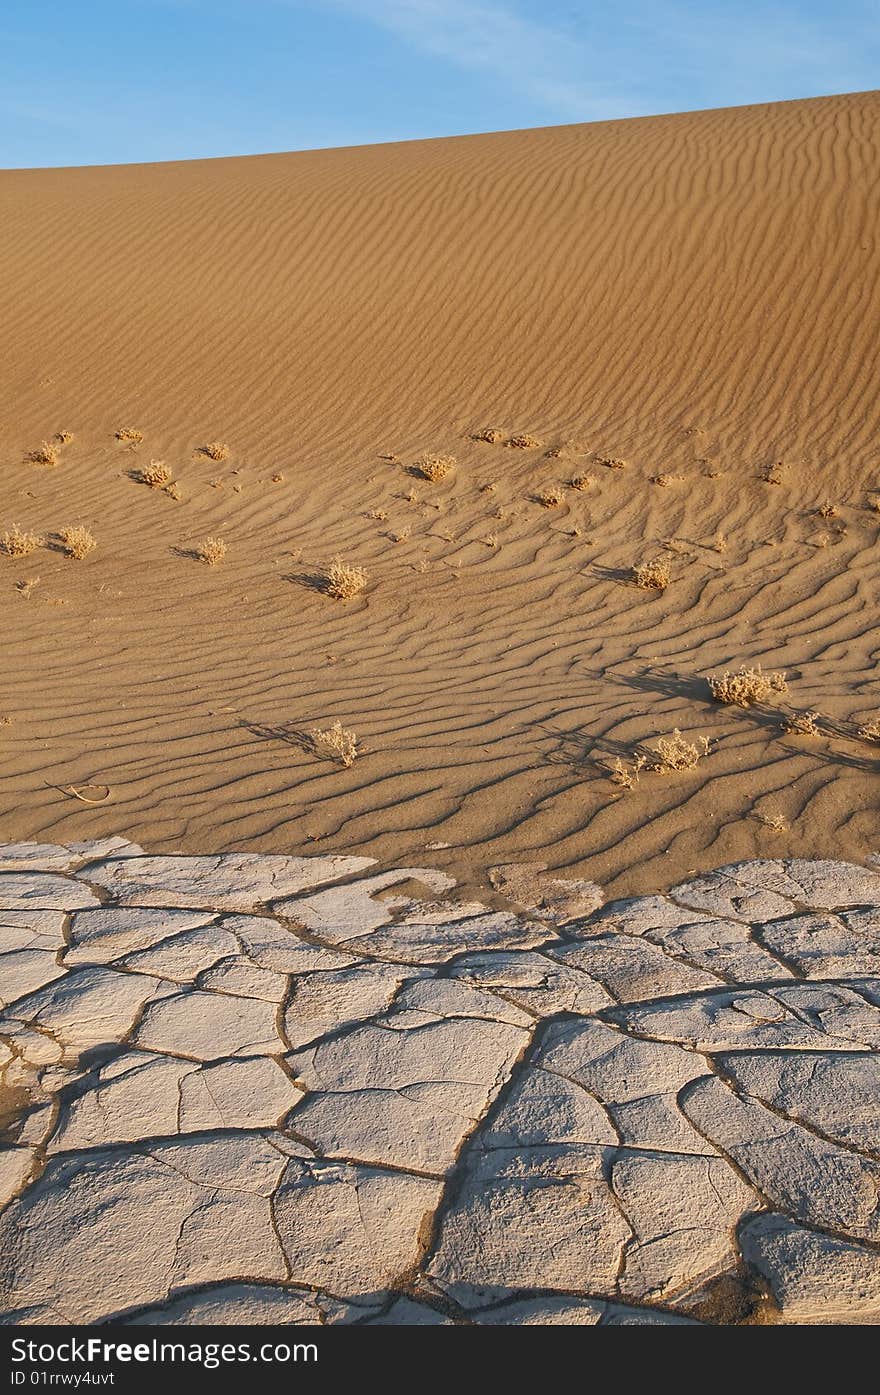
(0, 93, 880, 890)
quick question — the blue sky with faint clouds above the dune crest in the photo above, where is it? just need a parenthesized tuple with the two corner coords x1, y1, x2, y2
(0, 0, 880, 167)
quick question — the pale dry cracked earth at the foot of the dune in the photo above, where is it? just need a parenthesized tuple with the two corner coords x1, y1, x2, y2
(0, 838, 880, 1324)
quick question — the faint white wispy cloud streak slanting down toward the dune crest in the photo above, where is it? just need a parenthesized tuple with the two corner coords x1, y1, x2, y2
(316, 0, 633, 121)
